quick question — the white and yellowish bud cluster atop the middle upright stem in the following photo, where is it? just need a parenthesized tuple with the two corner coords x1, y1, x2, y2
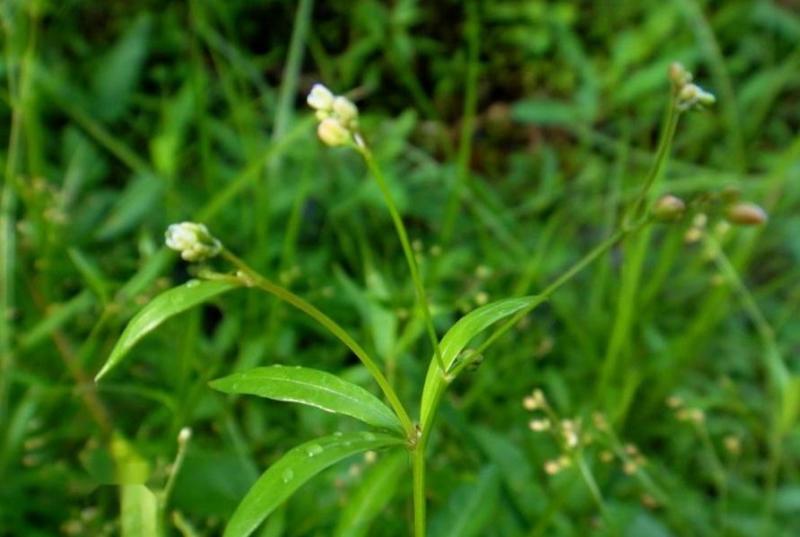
(306, 84, 358, 147)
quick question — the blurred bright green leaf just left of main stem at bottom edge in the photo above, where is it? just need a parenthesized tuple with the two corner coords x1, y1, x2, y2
(334, 451, 408, 537)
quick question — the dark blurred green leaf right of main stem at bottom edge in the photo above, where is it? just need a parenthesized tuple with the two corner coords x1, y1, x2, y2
(431, 466, 500, 537)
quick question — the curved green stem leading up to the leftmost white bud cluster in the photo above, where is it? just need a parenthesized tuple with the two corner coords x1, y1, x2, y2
(222, 250, 416, 438)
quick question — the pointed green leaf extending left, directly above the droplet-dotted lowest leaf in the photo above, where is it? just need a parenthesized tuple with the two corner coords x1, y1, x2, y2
(210, 365, 403, 432)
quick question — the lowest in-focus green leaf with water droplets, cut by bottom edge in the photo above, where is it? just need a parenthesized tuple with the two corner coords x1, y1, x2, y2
(224, 432, 403, 537)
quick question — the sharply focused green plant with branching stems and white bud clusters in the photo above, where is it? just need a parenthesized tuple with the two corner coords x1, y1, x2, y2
(89, 64, 776, 537)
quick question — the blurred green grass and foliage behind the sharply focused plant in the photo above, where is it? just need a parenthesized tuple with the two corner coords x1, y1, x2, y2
(0, 0, 800, 537)
